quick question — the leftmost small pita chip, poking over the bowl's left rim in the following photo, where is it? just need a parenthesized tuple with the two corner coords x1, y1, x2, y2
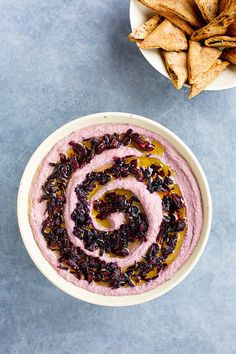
(128, 15, 162, 42)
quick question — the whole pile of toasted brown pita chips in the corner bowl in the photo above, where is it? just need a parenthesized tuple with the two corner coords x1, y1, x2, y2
(129, 0, 236, 98)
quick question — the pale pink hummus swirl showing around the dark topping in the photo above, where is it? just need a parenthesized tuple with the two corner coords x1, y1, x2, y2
(29, 124, 203, 295)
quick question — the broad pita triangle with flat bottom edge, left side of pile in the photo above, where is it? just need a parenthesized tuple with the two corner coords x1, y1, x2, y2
(139, 20, 188, 51)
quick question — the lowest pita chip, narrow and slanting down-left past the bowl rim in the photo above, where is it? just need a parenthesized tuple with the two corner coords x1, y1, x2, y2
(189, 59, 229, 98)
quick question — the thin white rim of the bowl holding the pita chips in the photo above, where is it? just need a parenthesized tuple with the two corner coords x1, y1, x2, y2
(129, 0, 236, 91)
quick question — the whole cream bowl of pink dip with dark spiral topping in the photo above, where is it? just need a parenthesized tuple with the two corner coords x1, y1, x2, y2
(17, 112, 212, 306)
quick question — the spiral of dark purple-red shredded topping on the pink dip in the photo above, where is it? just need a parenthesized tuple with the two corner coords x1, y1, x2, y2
(41, 129, 186, 288)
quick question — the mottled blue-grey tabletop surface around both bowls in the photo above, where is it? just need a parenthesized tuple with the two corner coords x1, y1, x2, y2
(0, 0, 236, 354)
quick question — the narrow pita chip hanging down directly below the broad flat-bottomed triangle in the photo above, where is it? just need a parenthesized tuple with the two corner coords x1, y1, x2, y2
(162, 50, 188, 90)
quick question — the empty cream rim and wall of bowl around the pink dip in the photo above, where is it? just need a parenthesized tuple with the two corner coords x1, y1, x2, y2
(17, 112, 212, 306)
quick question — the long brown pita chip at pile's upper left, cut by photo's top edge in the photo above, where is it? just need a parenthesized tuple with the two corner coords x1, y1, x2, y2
(139, 0, 203, 28)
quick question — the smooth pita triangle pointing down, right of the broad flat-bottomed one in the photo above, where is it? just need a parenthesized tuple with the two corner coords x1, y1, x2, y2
(188, 41, 221, 84)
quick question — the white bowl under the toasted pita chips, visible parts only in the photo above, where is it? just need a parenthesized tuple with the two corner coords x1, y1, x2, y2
(130, 0, 236, 91)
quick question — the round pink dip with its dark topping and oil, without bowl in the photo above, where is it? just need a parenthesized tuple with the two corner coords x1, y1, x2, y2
(29, 124, 203, 295)
